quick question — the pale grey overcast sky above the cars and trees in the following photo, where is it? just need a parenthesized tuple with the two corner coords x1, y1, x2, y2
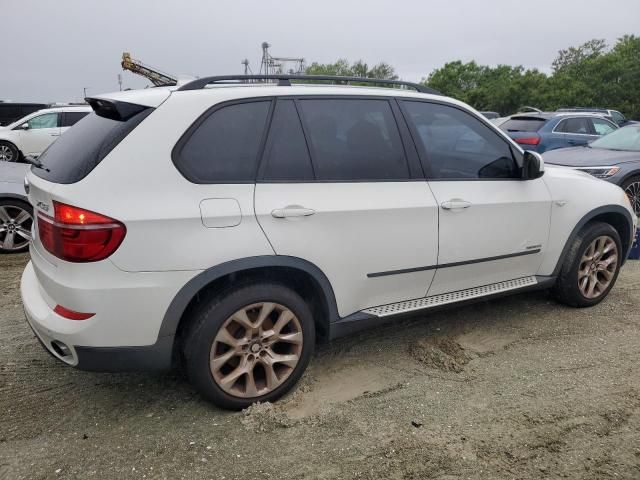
(5, 0, 640, 102)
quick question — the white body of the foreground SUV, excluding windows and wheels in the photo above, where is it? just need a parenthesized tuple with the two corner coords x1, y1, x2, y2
(21, 81, 636, 378)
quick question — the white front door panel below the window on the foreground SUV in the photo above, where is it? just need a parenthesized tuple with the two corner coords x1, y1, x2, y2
(429, 178, 551, 295)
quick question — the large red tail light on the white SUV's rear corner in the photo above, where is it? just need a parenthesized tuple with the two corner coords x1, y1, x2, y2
(38, 201, 127, 262)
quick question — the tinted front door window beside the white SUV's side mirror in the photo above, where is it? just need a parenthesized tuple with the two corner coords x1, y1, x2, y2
(404, 101, 518, 179)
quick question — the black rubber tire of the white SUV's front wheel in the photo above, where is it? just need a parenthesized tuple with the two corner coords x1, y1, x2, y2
(553, 222, 622, 307)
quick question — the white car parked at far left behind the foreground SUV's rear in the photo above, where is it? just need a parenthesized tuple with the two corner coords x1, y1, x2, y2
(0, 105, 91, 162)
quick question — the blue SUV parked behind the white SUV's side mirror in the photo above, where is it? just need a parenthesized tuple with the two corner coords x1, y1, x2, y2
(500, 112, 618, 153)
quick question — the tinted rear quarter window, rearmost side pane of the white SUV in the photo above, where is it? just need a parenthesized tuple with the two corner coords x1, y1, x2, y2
(175, 101, 271, 183)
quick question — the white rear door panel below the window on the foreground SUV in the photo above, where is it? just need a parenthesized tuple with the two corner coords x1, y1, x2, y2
(255, 181, 438, 317)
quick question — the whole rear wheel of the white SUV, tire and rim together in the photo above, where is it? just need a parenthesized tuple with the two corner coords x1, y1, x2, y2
(183, 284, 315, 410)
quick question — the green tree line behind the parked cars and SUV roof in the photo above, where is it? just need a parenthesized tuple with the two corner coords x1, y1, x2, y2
(305, 35, 640, 119)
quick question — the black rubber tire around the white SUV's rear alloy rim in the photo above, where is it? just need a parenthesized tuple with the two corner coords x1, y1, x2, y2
(182, 283, 315, 410)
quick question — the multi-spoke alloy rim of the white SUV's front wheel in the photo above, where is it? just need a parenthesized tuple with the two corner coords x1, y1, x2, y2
(578, 235, 618, 298)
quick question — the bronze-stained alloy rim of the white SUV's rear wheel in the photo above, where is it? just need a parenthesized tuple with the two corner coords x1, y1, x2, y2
(210, 302, 303, 398)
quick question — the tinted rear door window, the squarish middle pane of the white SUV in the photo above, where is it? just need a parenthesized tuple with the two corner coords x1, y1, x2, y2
(300, 99, 409, 181)
